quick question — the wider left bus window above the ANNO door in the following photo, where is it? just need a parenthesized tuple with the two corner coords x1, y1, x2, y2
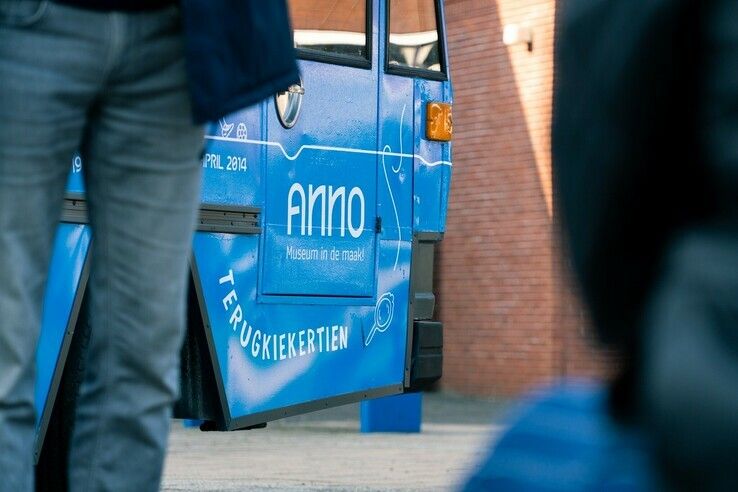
(289, 0, 369, 61)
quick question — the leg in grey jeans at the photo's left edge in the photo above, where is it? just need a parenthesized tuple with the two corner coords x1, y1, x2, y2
(0, 0, 99, 491)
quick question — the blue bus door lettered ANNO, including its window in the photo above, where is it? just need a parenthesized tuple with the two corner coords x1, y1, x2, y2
(260, 0, 377, 302)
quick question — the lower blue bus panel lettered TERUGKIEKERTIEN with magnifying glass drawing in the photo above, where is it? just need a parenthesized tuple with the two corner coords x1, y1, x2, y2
(193, 232, 410, 428)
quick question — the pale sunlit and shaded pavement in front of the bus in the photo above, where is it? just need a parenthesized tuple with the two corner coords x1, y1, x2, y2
(162, 394, 507, 491)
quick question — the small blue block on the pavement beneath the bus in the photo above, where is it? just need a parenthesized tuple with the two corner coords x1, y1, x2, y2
(361, 393, 423, 432)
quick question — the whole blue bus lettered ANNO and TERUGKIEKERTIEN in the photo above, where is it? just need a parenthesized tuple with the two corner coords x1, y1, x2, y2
(36, 0, 452, 466)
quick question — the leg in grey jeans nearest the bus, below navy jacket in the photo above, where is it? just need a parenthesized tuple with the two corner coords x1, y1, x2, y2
(70, 9, 204, 491)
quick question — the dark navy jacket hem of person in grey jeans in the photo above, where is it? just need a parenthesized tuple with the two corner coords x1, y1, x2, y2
(182, 0, 299, 122)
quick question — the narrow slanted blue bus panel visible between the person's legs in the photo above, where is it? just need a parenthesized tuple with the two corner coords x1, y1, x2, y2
(36, 224, 90, 423)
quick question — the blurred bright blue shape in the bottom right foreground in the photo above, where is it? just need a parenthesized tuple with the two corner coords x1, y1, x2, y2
(463, 382, 662, 492)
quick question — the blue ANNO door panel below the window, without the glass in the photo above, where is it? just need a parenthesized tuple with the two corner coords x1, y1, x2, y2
(260, 60, 379, 302)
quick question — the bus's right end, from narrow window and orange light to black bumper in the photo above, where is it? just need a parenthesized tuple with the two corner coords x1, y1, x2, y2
(379, 0, 452, 387)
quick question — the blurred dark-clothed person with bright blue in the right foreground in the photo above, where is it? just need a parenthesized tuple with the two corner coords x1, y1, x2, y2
(468, 0, 738, 490)
